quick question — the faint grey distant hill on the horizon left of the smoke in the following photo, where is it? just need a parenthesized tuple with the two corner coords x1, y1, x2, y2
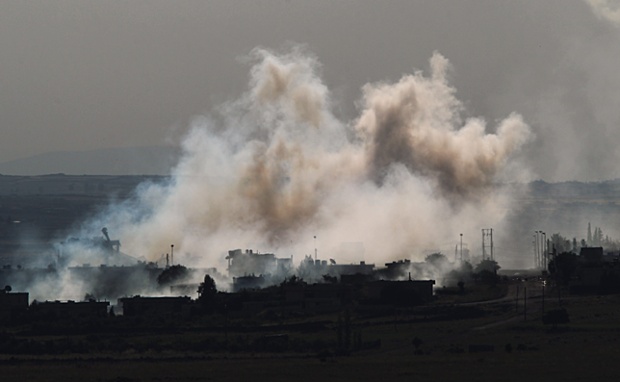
(0, 146, 179, 175)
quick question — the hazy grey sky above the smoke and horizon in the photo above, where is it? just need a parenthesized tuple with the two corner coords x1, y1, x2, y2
(0, 0, 620, 180)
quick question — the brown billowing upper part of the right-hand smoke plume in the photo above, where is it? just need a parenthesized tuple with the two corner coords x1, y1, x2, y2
(356, 53, 529, 198)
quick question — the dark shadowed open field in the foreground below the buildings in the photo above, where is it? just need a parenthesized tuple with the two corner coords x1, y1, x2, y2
(0, 286, 620, 381)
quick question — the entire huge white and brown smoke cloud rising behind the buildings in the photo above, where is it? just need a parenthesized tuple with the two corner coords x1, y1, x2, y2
(68, 49, 531, 274)
